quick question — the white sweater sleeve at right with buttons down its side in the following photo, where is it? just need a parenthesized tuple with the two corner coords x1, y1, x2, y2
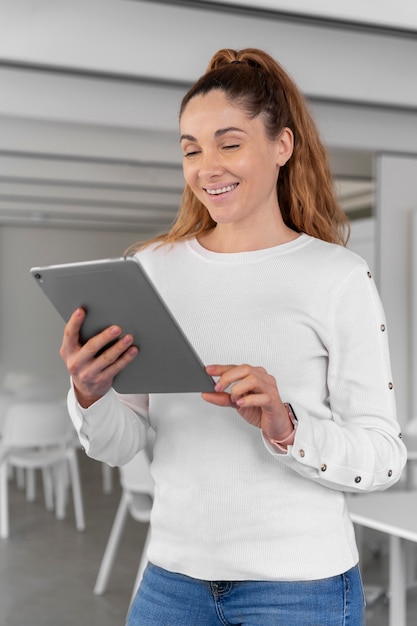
(265, 265, 406, 492)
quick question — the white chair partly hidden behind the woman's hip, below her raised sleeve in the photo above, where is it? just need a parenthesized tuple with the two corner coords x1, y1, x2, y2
(94, 450, 154, 599)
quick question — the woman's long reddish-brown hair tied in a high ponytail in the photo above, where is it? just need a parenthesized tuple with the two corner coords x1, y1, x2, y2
(130, 48, 349, 251)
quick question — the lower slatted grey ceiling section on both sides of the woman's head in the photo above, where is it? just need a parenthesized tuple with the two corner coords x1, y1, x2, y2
(0, 147, 374, 233)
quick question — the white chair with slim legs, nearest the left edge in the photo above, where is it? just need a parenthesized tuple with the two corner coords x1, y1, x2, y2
(0, 400, 85, 538)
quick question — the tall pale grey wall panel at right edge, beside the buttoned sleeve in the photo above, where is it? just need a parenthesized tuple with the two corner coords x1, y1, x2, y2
(376, 154, 417, 424)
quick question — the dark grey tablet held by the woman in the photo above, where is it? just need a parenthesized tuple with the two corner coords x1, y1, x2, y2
(30, 257, 214, 393)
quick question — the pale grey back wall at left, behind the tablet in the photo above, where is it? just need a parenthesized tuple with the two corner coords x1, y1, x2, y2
(0, 227, 147, 394)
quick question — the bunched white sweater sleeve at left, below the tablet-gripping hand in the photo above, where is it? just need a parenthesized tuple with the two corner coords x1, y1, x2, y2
(67, 378, 149, 466)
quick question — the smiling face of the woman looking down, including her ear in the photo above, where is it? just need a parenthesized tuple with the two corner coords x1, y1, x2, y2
(180, 89, 292, 226)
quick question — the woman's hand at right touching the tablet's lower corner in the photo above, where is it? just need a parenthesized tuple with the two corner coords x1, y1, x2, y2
(202, 365, 293, 440)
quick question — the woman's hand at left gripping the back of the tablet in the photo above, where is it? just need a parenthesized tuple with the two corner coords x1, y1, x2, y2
(60, 308, 138, 408)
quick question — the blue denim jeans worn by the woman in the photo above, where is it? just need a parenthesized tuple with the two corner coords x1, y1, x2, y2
(126, 563, 365, 626)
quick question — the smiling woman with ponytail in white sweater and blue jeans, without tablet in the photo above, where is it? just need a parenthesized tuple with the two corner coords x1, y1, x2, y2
(61, 49, 406, 626)
